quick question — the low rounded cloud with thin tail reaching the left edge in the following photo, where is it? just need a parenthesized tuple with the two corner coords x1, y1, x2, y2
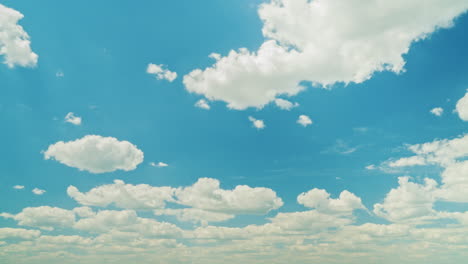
(0, 206, 75, 230)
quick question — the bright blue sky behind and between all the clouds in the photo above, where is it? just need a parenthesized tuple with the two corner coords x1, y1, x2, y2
(0, 0, 468, 263)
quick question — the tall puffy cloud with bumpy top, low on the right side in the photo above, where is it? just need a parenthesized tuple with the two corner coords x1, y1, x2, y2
(374, 177, 438, 223)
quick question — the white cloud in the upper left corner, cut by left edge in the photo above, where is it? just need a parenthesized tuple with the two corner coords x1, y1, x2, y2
(0, 4, 38, 68)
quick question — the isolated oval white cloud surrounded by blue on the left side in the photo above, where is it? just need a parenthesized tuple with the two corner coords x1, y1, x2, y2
(44, 135, 143, 173)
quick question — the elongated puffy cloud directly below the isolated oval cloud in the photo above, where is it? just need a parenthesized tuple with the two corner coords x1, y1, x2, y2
(67, 180, 174, 209)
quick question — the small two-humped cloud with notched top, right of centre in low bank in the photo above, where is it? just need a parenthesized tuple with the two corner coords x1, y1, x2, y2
(297, 189, 365, 214)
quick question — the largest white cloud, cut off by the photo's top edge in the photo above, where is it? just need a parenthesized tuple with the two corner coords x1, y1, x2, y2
(183, 0, 468, 110)
